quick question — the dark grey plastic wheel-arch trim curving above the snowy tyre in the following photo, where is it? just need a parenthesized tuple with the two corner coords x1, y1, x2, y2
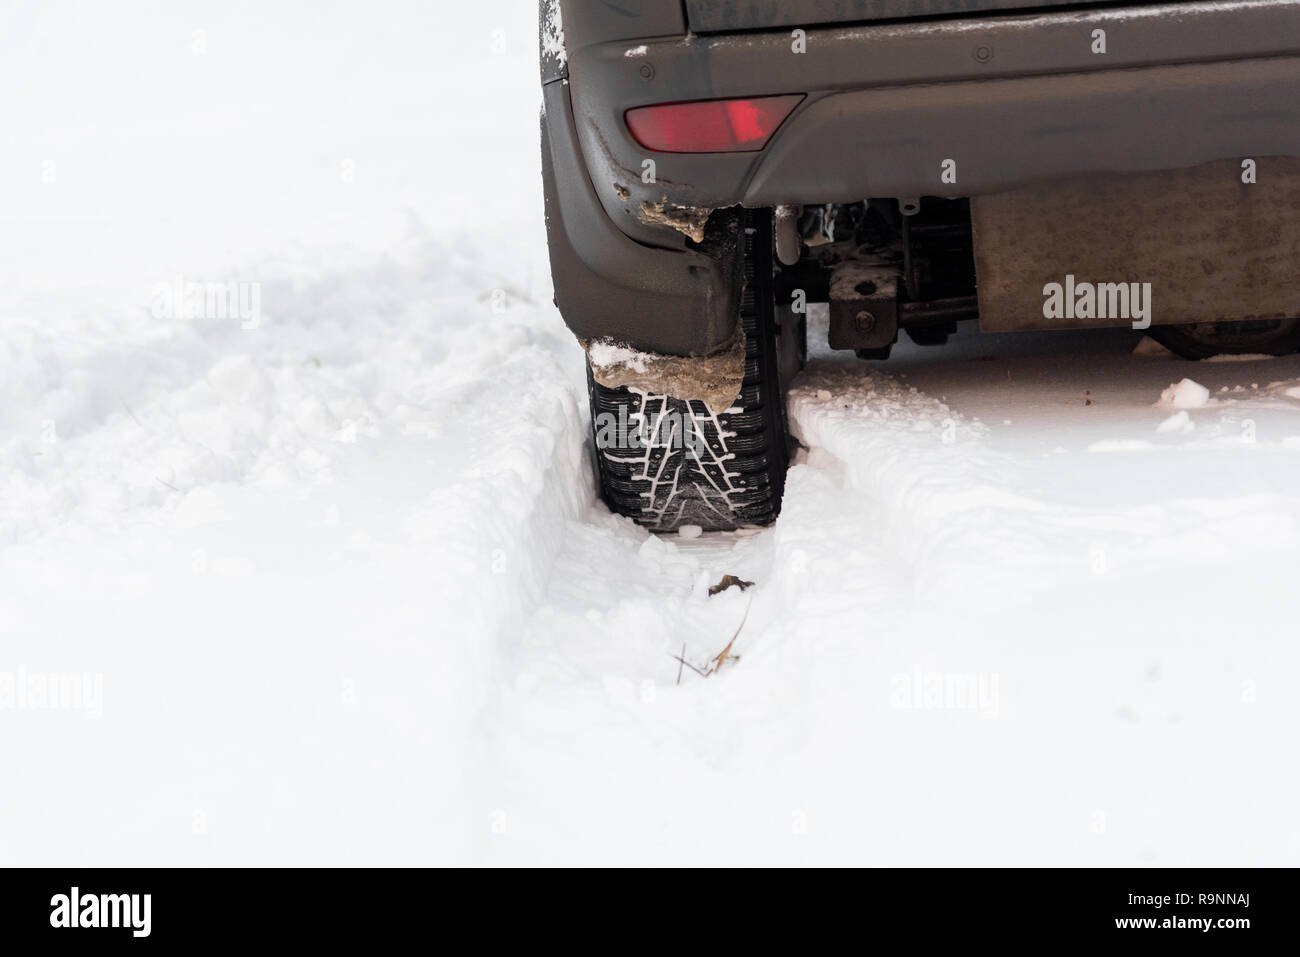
(542, 82, 741, 356)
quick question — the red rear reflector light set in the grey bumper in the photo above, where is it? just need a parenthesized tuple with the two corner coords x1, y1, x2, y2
(625, 94, 803, 153)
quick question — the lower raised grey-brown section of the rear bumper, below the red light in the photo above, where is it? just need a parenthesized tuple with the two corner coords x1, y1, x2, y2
(744, 57, 1300, 205)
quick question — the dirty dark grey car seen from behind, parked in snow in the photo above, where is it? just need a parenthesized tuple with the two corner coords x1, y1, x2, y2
(540, 0, 1300, 532)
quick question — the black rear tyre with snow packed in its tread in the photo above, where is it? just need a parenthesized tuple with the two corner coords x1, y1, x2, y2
(588, 211, 803, 532)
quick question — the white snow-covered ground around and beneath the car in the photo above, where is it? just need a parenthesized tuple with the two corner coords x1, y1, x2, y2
(0, 0, 1300, 865)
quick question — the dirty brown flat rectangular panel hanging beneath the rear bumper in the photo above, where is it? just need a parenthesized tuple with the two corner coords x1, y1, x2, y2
(971, 157, 1300, 332)
